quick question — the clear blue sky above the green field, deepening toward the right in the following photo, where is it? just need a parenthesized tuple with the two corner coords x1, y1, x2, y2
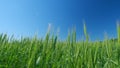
(0, 0, 120, 40)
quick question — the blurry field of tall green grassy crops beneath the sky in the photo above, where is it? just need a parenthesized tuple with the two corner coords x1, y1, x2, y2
(0, 25, 120, 68)
